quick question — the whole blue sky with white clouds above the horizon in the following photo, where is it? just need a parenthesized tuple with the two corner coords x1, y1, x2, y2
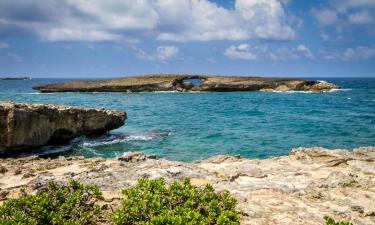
(0, 0, 375, 78)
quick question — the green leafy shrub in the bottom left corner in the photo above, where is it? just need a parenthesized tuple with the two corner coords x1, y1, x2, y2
(0, 181, 102, 225)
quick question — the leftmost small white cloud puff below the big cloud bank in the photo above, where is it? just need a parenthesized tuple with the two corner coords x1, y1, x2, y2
(136, 46, 179, 61)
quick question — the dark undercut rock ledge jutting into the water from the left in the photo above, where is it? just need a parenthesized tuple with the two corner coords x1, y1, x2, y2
(0, 102, 126, 154)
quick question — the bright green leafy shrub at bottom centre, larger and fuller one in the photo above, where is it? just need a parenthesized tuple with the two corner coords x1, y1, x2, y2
(112, 178, 239, 225)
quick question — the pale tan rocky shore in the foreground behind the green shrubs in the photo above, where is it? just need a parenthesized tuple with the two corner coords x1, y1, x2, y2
(0, 147, 375, 225)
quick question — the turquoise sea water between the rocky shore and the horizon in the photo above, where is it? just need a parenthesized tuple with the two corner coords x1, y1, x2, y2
(0, 78, 375, 161)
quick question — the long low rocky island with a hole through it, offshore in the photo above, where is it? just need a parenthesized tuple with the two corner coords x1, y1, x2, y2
(33, 74, 339, 92)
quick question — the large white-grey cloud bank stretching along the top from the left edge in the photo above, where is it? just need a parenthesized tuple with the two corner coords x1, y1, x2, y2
(0, 0, 295, 41)
